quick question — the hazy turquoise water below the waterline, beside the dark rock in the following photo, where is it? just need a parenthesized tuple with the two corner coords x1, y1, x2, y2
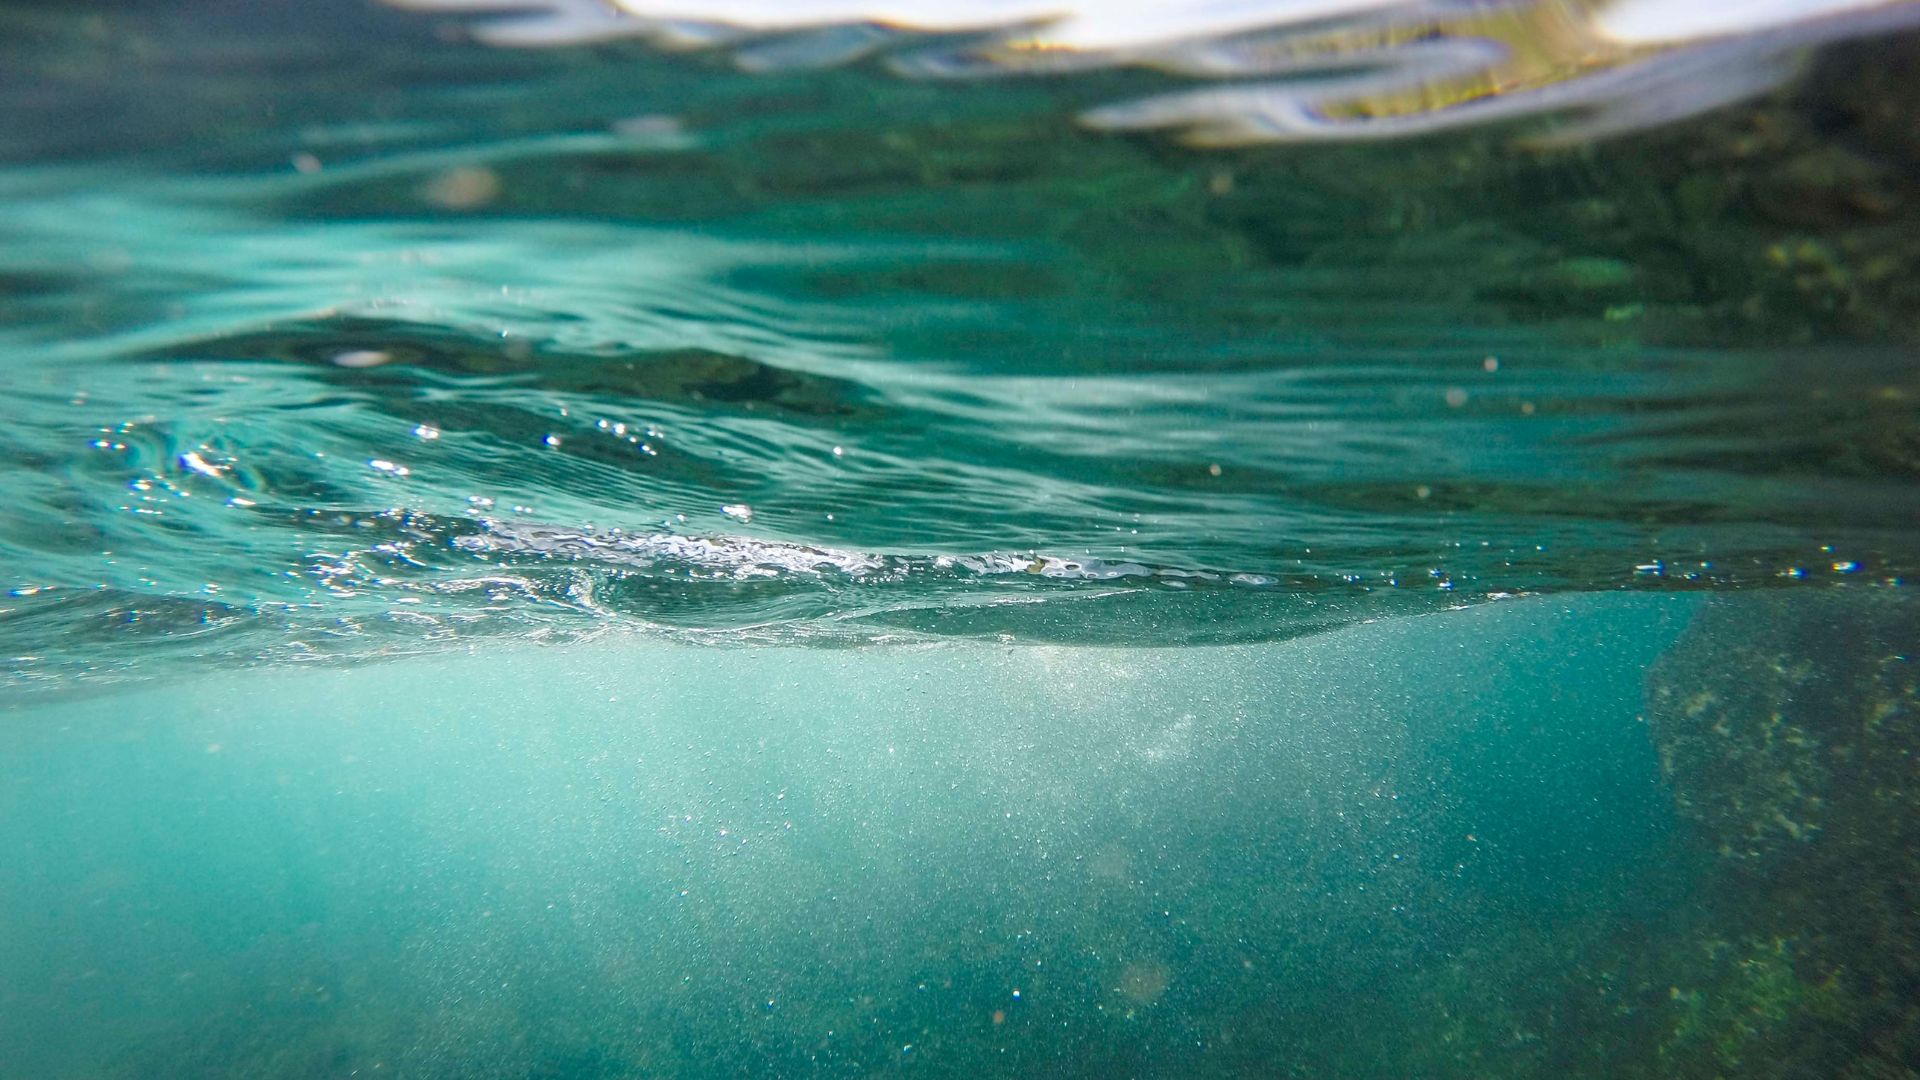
(0, 600, 1690, 1076)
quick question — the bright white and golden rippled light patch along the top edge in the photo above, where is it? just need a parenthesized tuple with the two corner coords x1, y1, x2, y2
(390, 0, 1920, 144)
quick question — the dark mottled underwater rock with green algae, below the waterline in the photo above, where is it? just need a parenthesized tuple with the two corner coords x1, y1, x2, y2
(1647, 590, 1920, 1076)
